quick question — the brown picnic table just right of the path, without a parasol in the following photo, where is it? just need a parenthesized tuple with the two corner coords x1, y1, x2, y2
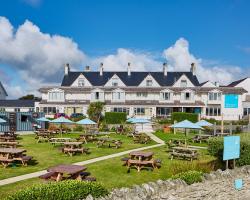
(125, 151, 160, 172)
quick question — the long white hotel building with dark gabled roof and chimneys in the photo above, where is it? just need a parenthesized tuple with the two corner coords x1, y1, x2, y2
(38, 63, 246, 120)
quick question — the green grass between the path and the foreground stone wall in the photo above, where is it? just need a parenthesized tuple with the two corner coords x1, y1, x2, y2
(0, 146, 217, 197)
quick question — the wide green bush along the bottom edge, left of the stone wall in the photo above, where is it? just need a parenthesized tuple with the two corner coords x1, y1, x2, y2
(6, 180, 108, 200)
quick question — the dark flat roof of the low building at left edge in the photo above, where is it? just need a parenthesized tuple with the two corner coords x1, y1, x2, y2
(0, 100, 35, 108)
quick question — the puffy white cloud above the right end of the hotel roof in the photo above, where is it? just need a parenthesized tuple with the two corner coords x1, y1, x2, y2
(163, 38, 242, 84)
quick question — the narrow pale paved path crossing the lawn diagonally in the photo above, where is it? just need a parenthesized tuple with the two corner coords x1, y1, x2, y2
(0, 133, 164, 186)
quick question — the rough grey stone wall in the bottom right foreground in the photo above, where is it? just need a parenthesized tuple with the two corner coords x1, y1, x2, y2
(87, 166, 250, 200)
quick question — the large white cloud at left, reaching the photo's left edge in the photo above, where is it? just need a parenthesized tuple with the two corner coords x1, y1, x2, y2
(0, 17, 85, 98)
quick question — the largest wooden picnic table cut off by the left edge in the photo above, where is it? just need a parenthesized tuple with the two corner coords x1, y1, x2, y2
(0, 148, 32, 168)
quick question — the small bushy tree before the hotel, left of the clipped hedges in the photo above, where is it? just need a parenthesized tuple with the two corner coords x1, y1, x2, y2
(87, 101, 104, 124)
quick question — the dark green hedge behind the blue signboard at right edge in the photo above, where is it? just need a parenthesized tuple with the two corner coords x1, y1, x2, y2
(208, 134, 250, 166)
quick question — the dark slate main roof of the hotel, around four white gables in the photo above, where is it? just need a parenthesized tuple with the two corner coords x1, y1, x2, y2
(61, 71, 200, 86)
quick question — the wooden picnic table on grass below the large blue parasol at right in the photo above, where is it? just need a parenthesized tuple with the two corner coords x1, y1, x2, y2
(170, 147, 198, 161)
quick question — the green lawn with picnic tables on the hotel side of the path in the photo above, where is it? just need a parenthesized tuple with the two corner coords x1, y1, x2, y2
(0, 133, 155, 180)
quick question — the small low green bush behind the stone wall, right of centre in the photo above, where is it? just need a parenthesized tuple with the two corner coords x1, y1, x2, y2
(172, 171, 203, 185)
